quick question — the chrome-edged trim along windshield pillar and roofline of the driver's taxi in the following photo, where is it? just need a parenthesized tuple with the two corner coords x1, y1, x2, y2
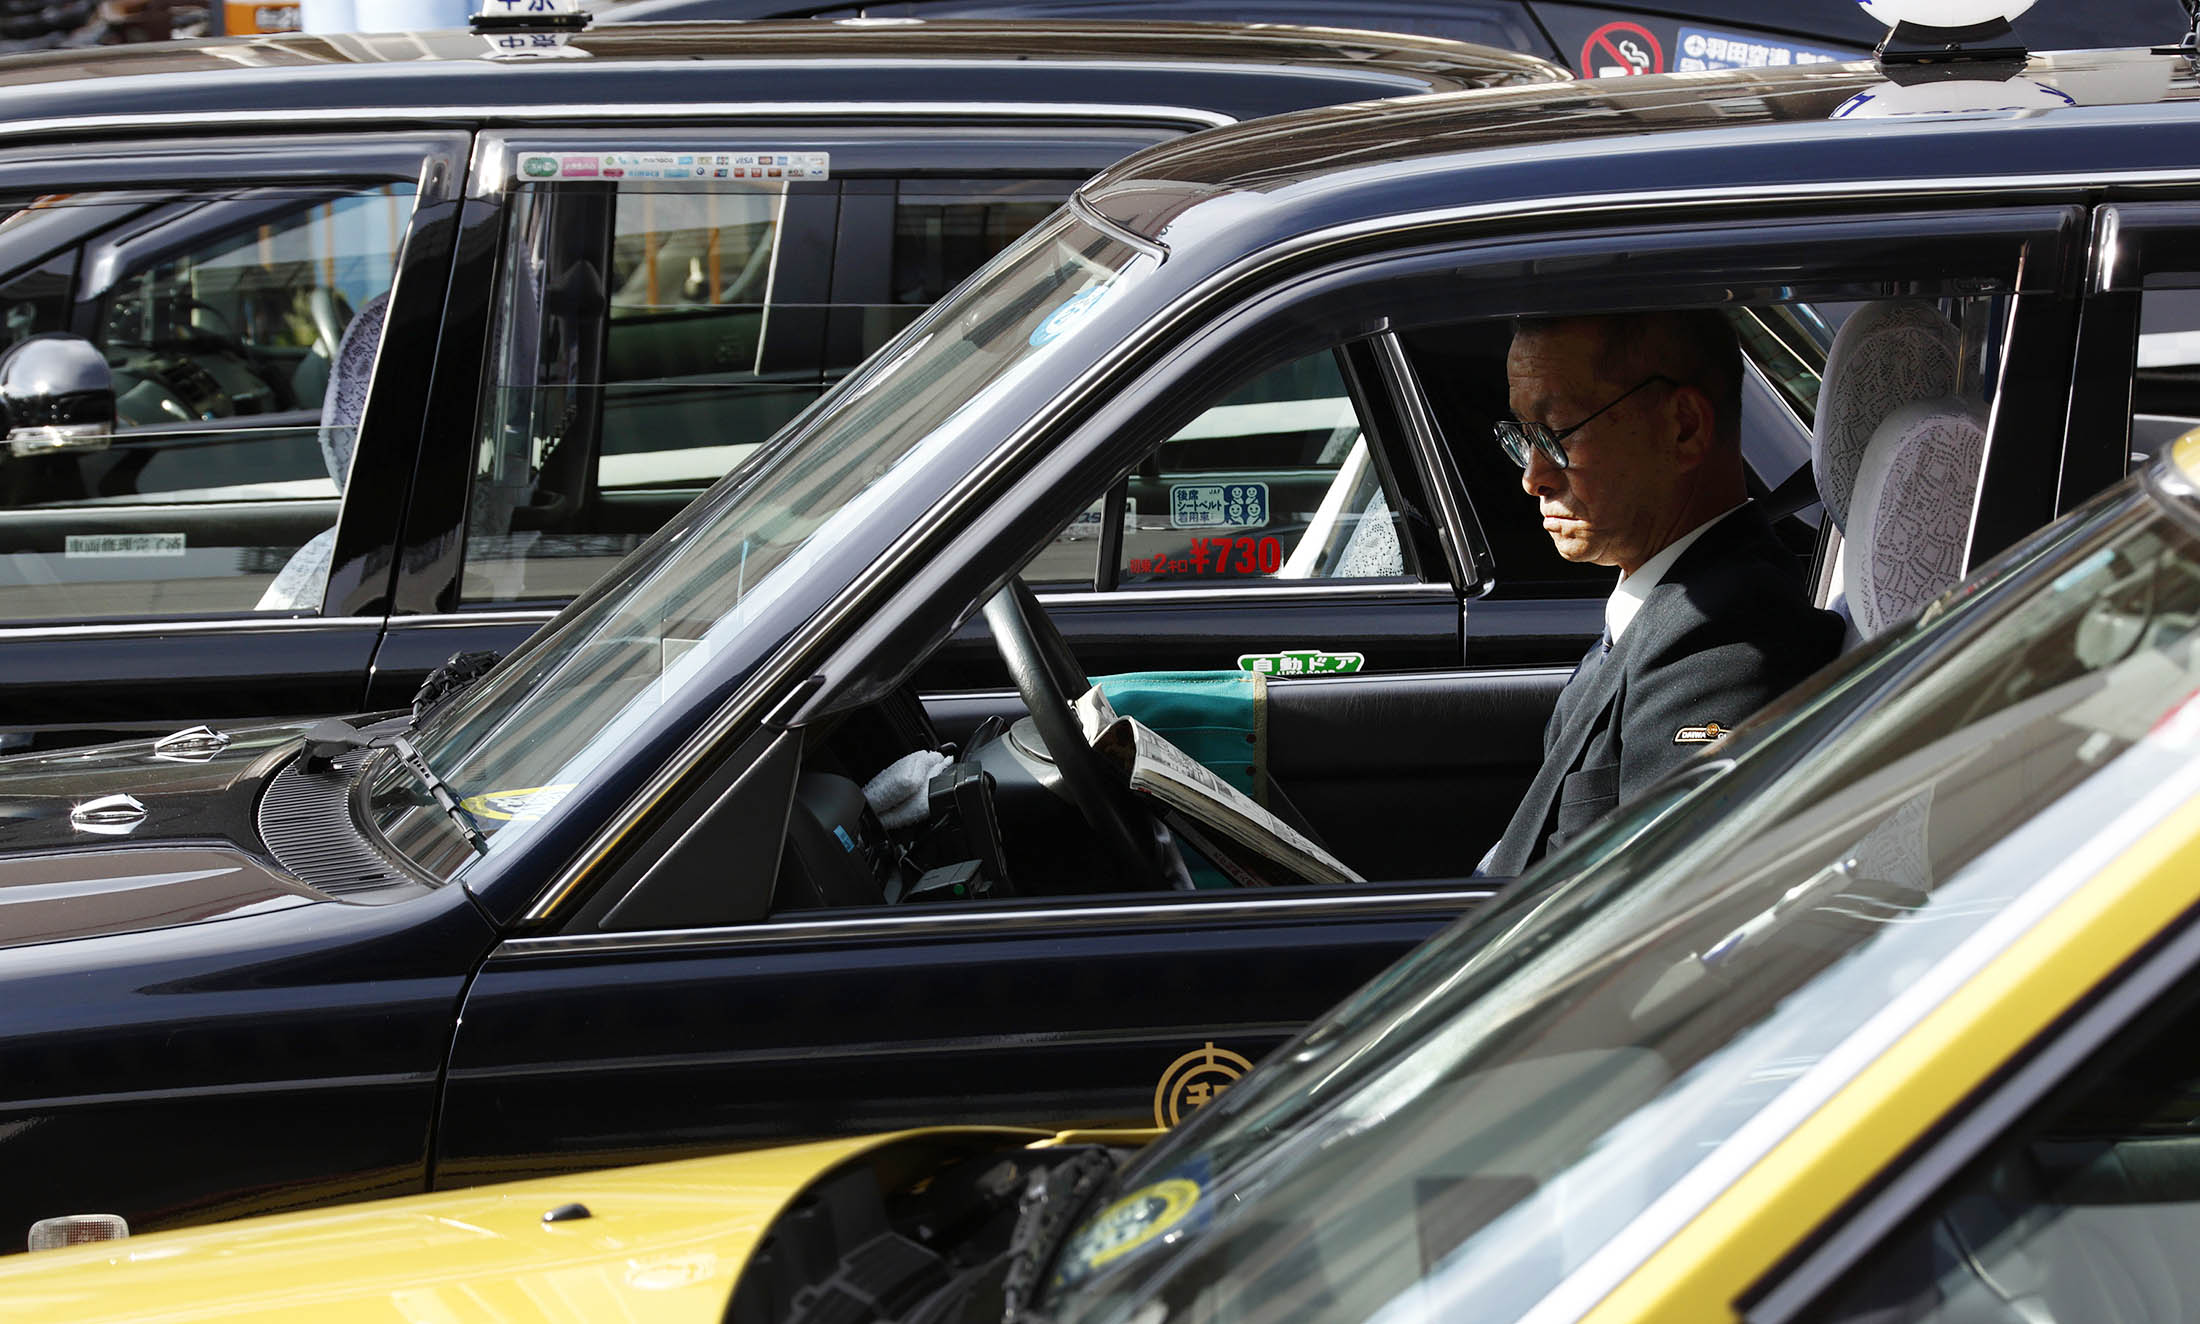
(519, 167, 2129, 924)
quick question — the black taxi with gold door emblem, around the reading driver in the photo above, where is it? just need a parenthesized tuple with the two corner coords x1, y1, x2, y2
(0, 15, 2200, 1249)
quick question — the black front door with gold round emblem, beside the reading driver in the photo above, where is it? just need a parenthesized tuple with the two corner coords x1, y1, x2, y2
(438, 195, 2081, 1181)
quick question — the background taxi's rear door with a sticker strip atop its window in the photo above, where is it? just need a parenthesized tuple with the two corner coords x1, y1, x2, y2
(372, 119, 1173, 706)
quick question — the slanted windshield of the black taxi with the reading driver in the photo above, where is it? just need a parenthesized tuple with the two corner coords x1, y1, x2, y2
(370, 213, 1142, 875)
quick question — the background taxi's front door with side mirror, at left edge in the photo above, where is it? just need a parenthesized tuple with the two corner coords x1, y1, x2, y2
(0, 132, 466, 748)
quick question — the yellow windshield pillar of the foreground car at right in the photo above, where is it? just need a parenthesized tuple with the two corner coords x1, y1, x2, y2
(1584, 801, 2200, 1324)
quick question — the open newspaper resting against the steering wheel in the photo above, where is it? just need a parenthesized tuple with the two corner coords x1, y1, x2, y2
(1074, 686, 1366, 886)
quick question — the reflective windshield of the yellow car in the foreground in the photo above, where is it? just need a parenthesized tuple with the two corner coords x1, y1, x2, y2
(1049, 475, 2200, 1322)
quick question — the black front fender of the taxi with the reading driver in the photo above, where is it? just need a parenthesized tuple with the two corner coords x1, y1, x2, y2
(0, 875, 493, 1227)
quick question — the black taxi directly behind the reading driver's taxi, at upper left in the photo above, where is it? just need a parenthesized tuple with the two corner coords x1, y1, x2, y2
(0, 22, 1566, 748)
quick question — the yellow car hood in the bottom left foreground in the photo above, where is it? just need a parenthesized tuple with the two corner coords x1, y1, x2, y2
(0, 1128, 1049, 1324)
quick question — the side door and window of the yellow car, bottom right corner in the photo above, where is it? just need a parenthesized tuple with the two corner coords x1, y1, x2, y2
(1747, 844, 2200, 1324)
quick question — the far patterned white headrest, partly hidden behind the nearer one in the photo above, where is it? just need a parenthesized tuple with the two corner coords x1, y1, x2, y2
(1811, 299, 1960, 527)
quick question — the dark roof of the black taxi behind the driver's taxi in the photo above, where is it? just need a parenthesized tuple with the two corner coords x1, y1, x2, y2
(0, 20, 1569, 139)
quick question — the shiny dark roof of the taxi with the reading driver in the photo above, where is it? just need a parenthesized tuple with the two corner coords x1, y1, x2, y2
(1078, 51, 2200, 249)
